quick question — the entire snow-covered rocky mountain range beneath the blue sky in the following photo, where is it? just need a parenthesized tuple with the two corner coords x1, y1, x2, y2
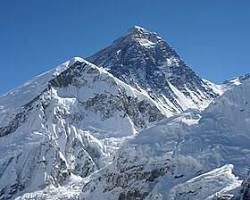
(0, 26, 250, 200)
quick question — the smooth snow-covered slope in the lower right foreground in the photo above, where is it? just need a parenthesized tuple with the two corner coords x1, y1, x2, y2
(78, 76, 250, 200)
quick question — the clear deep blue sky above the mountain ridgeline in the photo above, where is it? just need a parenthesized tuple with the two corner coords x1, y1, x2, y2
(0, 0, 250, 94)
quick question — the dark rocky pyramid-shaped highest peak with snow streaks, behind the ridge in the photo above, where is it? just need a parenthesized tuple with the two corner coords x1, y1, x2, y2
(87, 26, 221, 116)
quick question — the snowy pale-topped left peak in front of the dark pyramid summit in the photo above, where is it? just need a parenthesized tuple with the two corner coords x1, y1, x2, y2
(0, 58, 164, 199)
